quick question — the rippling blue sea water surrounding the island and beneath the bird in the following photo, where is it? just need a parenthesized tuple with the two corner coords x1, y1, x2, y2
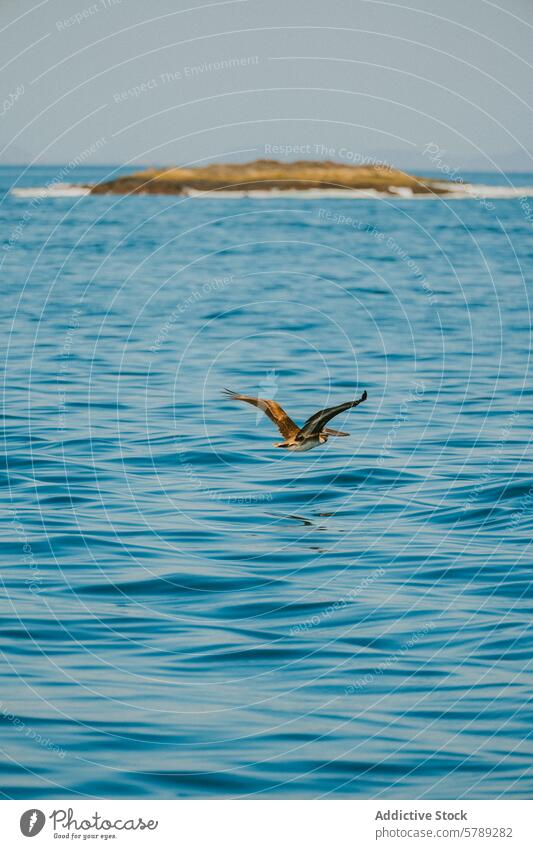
(0, 166, 533, 799)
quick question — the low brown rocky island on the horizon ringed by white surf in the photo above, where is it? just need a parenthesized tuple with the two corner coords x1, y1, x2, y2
(86, 159, 457, 197)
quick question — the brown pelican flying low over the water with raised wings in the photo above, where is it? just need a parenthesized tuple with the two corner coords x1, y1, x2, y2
(220, 389, 368, 451)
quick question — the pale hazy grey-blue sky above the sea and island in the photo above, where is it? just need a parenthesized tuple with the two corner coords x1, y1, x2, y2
(0, 0, 533, 176)
